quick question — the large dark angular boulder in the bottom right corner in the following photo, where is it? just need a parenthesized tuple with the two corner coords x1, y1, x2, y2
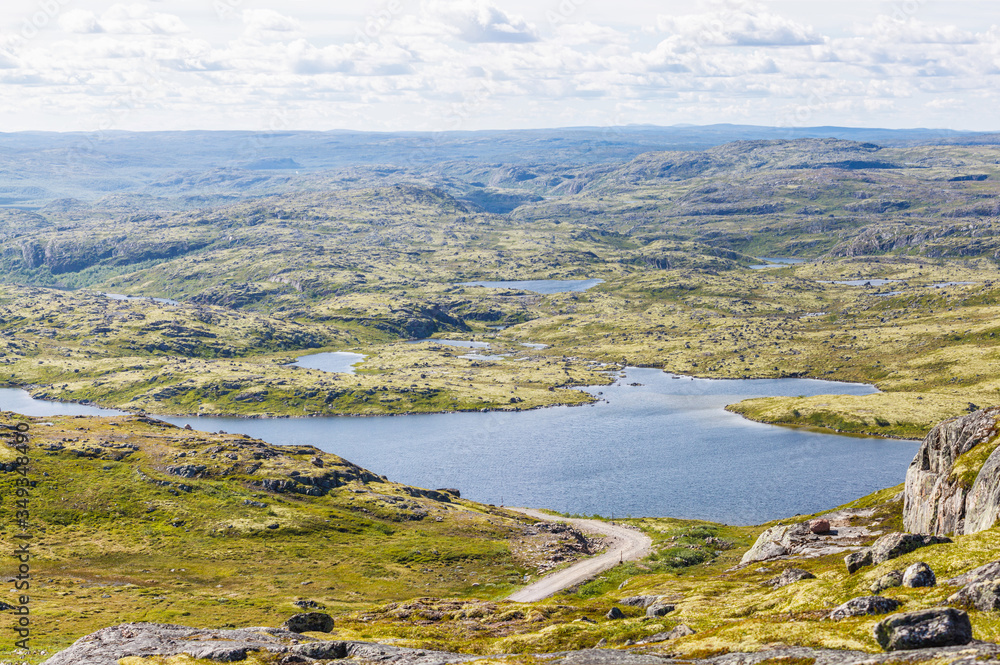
(874, 607, 972, 651)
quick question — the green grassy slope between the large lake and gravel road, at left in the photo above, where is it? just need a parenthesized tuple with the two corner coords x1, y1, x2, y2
(0, 413, 580, 653)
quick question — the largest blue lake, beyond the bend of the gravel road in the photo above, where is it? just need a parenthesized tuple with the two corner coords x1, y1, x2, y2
(0, 368, 917, 524)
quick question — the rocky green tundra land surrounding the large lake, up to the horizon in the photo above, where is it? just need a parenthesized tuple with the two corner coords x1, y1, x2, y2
(0, 126, 1000, 665)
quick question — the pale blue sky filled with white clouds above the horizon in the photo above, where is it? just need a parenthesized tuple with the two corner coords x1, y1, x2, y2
(0, 0, 1000, 131)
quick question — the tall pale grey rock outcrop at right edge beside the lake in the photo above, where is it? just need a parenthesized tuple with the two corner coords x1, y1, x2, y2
(903, 407, 1000, 535)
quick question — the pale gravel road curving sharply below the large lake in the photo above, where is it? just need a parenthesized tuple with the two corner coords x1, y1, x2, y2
(507, 508, 653, 603)
